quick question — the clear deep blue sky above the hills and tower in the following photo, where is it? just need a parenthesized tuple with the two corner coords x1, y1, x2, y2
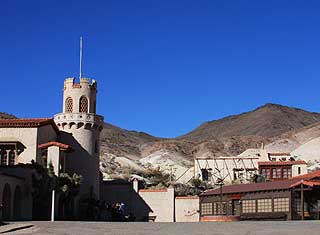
(0, 0, 320, 137)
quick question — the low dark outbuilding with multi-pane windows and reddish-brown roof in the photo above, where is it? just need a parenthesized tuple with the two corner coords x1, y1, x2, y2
(200, 171, 320, 221)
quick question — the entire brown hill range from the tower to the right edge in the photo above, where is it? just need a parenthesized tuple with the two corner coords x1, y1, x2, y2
(101, 104, 320, 159)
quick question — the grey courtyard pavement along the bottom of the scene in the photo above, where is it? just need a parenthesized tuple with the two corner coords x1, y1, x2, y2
(0, 221, 320, 235)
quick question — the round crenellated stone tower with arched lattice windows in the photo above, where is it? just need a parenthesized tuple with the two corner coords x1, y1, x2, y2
(54, 78, 103, 198)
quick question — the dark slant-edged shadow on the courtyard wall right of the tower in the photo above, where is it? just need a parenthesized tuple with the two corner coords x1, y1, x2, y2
(100, 179, 153, 221)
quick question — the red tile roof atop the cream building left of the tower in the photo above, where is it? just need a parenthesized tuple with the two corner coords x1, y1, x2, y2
(0, 118, 59, 131)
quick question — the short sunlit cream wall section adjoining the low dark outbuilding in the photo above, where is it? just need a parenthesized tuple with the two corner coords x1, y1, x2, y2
(175, 196, 199, 222)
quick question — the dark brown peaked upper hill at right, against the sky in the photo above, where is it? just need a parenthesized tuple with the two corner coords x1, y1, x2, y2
(180, 104, 320, 141)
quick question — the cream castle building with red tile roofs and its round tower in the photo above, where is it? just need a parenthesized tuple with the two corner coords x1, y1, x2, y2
(0, 78, 103, 220)
